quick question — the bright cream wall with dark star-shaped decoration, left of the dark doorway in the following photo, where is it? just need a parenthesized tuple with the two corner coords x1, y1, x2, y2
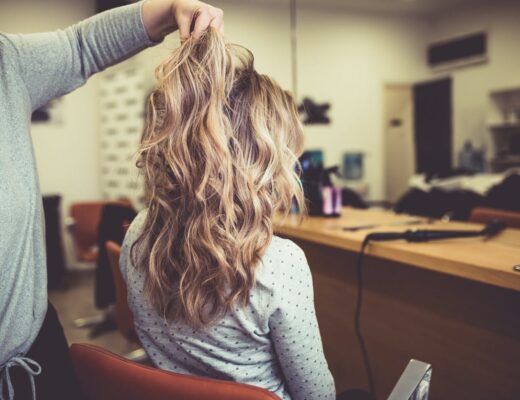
(298, 7, 429, 200)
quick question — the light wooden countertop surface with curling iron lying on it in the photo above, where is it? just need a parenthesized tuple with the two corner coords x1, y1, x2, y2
(276, 208, 520, 291)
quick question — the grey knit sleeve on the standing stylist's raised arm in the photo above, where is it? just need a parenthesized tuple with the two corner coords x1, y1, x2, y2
(3, 2, 154, 110)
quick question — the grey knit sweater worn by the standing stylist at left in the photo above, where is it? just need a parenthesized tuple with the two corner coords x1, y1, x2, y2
(0, 3, 152, 397)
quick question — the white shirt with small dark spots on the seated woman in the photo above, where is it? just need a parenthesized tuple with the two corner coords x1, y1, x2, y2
(120, 212, 336, 400)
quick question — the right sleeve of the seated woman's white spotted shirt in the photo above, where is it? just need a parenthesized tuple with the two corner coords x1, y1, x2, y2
(269, 242, 336, 400)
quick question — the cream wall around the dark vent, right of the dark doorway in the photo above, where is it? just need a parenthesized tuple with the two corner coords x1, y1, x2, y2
(431, 0, 520, 162)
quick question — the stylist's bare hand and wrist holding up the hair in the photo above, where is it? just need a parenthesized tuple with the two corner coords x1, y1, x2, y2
(143, 0, 224, 41)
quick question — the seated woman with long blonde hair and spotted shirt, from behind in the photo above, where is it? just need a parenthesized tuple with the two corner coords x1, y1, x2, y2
(121, 30, 335, 399)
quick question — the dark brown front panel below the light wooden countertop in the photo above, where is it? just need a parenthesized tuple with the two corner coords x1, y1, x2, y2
(291, 238, 520, 400)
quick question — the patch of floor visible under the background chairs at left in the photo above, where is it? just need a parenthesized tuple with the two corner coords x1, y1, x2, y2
(49, 270, 139, 355)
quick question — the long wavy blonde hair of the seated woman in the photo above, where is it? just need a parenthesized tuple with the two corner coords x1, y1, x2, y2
(132, 29, 305, 328)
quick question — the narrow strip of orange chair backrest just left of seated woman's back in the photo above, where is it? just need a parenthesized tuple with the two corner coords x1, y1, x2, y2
(106, 240, 135, 340)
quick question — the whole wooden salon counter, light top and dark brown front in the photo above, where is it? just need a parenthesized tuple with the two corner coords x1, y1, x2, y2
(276, 208, 520, 400)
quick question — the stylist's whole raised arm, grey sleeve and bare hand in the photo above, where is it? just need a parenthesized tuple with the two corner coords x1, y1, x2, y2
(6, 0, 224, 110)
